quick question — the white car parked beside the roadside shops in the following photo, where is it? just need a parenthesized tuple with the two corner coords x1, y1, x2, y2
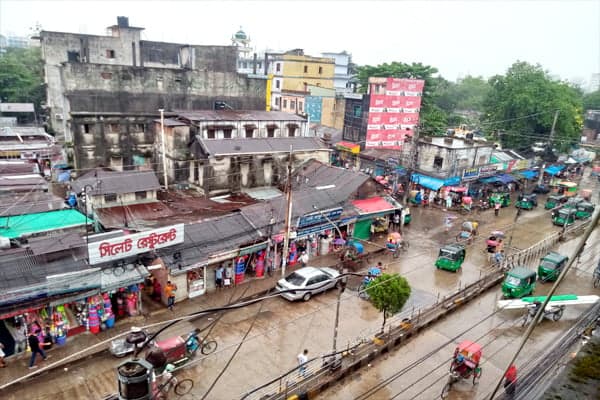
(276, 267, 341, 301)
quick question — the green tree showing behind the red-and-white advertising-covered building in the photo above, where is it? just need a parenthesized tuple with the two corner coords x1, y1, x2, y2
(356, 61, 446, 135)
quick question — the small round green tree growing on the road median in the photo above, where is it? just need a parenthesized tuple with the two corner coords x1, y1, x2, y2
(367, 274, 410, 332)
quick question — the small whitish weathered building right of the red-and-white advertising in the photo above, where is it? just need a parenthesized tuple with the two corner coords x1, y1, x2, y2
(416, 137, 494, 178)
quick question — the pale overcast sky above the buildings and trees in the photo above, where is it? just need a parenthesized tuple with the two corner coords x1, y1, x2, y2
(0, 0, 600, 83)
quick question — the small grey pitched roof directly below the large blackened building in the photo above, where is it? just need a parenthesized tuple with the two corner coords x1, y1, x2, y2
(71, 169, 160, 196)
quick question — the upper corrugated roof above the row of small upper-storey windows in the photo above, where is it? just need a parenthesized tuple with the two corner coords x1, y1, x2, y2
(175, 110, 306, 122)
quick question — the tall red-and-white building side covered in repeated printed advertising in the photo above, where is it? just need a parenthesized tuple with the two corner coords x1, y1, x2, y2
(365, 77, 425, 150)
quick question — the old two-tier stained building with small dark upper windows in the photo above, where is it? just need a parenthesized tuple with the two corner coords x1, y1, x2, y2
(155, 110, 329, 196)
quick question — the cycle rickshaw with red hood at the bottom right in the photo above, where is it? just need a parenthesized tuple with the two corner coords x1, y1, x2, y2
(441, 340, 483, 399)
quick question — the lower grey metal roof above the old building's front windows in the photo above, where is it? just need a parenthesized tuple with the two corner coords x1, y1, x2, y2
(196, 136, 327, 156)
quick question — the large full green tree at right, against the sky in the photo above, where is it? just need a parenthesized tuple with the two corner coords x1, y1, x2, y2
(484, 61, 583, 152)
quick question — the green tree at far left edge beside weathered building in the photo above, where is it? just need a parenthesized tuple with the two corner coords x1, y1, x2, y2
(0, 47, 46, 114)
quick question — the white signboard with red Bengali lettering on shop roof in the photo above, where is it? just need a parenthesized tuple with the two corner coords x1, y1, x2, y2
(88, 224, 184, 264)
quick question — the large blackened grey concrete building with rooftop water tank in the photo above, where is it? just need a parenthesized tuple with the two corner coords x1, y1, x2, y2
(40, 17, 266, 169)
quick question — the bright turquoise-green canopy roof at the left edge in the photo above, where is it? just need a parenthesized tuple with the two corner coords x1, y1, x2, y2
(0, 208, 88, 239)
